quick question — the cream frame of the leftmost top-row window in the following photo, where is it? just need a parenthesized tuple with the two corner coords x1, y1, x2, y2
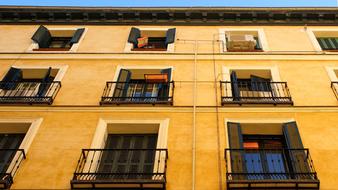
(27, 27, 88, 53)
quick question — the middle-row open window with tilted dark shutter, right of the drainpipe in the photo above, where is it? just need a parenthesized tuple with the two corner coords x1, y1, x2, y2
(221, 69, 292, 104)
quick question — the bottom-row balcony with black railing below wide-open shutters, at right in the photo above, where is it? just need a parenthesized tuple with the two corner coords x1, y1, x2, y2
(225, 149, 319, 190)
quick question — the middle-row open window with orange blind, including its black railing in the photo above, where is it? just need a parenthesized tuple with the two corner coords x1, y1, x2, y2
(101, 68, 174, 105)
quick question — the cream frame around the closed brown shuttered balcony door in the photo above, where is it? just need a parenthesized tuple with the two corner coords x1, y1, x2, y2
(84, 118, 169, 179)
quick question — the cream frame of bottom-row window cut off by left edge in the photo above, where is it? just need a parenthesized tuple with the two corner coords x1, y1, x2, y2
(0, 118, 43, 177)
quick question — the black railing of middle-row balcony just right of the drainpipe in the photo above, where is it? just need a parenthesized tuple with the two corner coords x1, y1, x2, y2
(220, 81, 293, 105)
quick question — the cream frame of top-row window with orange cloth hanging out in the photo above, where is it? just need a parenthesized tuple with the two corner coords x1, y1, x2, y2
(124, 28, 177, 53)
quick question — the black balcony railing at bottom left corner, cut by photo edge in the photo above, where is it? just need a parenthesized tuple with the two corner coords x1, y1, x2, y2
(0, 149, 26, 189)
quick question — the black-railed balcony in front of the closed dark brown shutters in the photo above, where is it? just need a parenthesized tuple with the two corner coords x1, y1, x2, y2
(70, 149, 168, 190)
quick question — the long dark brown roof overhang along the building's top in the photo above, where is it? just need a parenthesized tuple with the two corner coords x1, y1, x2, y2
(0, 6, 338, 26)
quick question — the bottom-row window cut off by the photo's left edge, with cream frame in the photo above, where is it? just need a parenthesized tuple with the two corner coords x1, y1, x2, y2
(0, 119, 42, 189)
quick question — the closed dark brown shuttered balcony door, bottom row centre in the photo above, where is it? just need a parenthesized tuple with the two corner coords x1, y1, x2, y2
(98, 134, 157, 179)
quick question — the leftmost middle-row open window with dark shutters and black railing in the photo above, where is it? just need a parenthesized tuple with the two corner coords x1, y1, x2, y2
(0, 67, 61, 104)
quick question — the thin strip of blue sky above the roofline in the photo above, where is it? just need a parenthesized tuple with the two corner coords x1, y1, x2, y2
(0, 0, 338, 7)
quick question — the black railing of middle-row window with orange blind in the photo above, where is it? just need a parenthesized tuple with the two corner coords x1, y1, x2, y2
(100, 81, 175, 105)
